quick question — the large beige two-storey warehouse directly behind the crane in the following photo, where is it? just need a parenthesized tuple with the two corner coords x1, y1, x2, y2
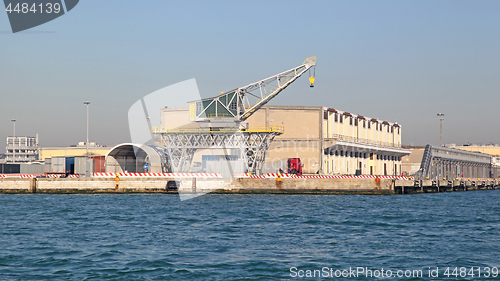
(248, 106, 410, 175)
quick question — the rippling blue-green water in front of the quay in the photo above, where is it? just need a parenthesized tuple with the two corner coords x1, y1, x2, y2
(0, 190, 500, 280)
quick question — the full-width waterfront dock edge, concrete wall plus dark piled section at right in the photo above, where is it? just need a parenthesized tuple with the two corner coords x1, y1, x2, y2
(0, 177, 500, 195)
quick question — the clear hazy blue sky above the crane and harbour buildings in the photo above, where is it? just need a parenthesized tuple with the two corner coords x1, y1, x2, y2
(0, 0, 500, 153)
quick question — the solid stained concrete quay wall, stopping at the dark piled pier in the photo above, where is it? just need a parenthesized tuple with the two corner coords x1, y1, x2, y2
(0, 178, 394, 193)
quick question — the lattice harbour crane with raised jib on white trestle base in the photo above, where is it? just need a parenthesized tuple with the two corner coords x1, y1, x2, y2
(152, 57, 316, 174)
